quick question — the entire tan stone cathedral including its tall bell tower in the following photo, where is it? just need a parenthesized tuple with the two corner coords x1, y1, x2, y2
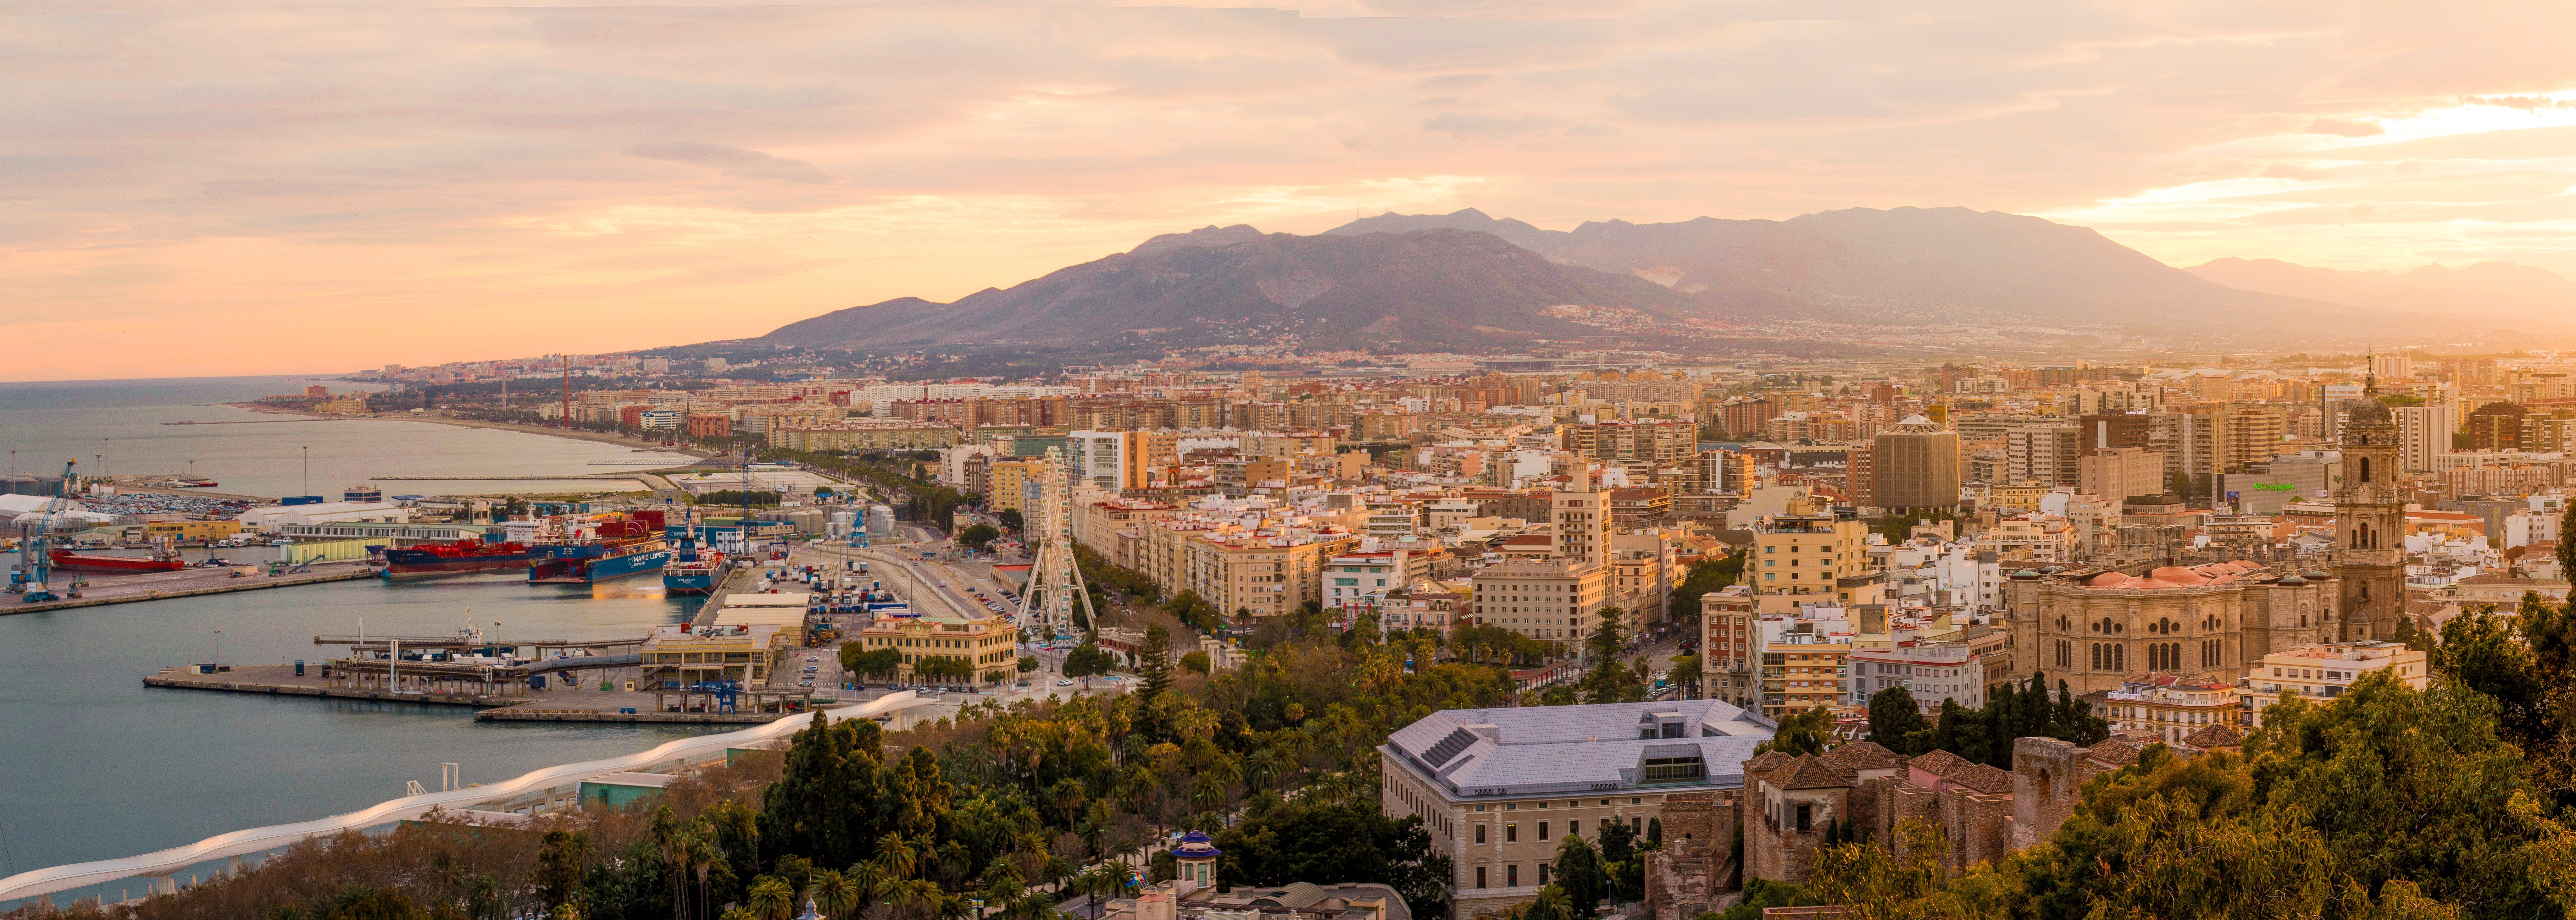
(1989, 384, 2406, 693)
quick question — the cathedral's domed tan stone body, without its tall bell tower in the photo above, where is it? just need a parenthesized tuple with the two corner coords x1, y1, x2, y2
(1986, 562, 2342, 693)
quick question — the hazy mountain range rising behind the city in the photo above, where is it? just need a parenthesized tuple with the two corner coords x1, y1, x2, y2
(763, 209, 2576, 348)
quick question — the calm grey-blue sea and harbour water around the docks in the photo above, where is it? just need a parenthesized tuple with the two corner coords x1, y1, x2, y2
(0, 376, 713, 910)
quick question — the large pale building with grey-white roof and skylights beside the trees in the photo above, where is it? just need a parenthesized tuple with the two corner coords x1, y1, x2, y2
(1378, 698, 1775, 917)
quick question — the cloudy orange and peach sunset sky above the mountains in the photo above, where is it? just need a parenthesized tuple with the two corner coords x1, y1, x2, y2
(0, 0, 2576, 379)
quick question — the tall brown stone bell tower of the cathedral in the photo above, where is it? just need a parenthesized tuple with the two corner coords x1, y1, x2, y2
(2334, 374, 2406, 639)
